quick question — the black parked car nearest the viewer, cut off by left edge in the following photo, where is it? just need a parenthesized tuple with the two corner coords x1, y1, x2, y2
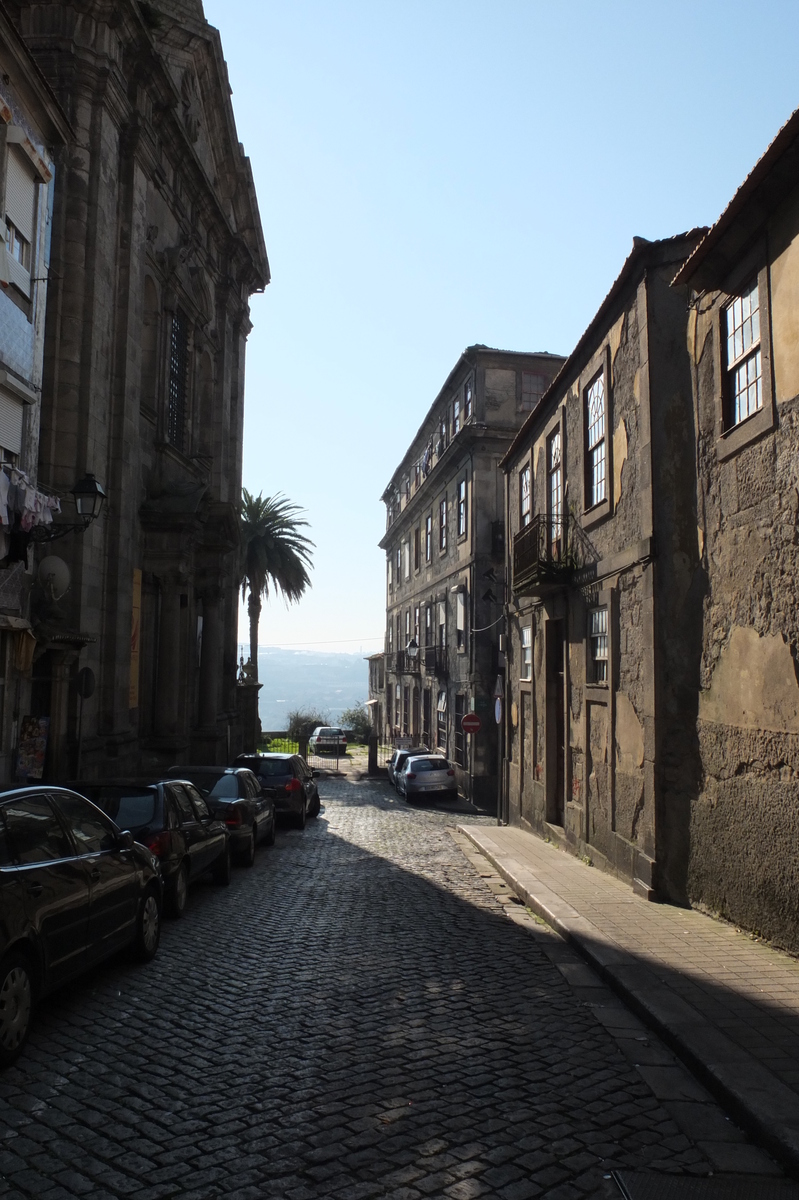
(0, 787, 163, 1067)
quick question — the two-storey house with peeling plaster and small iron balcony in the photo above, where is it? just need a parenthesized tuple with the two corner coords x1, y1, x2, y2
(501, 232, 701, 896)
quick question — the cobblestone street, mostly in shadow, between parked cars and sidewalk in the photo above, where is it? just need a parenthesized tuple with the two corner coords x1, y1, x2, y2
(0, 779, 769, 1200)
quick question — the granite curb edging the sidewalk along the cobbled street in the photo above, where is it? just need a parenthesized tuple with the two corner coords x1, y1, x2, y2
(458, 826, 799, 1176)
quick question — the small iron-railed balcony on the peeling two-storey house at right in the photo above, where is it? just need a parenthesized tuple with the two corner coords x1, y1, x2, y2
(513, 514, 599, 596)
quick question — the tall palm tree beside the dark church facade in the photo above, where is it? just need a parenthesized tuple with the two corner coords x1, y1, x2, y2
(240, 487, 313, 679)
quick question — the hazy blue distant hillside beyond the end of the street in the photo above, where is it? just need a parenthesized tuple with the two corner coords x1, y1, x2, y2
(258, 647, 368, 730)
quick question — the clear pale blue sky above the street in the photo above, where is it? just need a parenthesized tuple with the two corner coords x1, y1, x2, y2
(205, 0, 799, 653)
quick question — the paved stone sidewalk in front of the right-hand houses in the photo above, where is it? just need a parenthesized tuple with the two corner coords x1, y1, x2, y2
(461, 824, 799, 1174)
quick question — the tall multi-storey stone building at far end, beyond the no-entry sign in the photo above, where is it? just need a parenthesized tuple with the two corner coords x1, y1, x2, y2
(379, 346, 563, 811)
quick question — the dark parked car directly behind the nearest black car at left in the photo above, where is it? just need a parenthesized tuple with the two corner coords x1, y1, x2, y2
(73, 779, 230, 917)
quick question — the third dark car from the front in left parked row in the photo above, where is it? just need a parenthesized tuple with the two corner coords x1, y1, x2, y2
(167, 767, 275, 866)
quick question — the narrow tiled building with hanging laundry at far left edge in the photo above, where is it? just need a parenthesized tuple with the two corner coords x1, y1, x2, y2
(0, 5, 71, 785)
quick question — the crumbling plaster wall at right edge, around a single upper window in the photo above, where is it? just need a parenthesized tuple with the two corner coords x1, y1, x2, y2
(686, 206, 799, 950)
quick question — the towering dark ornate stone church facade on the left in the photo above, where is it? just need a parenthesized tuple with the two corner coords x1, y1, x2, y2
(10, 0, 269, 779)
